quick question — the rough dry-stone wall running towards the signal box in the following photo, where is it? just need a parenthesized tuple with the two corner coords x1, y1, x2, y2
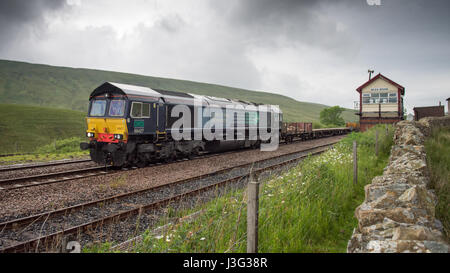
(347, 116, 450, 253)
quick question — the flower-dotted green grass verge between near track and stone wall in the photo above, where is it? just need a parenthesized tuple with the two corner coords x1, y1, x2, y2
(84, 124, 393, 253)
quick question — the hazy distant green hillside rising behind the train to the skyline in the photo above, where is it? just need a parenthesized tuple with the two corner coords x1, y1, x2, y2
(0, 60, 356, 121)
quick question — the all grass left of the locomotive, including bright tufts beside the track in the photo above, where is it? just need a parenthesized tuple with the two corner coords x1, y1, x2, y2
(0, 109, 89, 165)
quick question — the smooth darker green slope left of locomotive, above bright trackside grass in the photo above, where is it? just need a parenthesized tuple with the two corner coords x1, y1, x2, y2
(0, 104, 85, 154)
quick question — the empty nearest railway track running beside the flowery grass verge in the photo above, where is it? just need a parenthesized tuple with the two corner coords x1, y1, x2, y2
(0, 141, 337, 252)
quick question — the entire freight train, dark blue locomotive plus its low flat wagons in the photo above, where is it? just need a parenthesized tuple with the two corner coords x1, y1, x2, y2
(80, 82, 350, 167)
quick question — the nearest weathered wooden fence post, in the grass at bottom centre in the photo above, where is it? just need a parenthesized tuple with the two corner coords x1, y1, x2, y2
(247, 181, 259, 253)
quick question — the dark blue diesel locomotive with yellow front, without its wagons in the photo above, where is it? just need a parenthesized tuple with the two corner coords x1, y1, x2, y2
(80, 82, 283, 167)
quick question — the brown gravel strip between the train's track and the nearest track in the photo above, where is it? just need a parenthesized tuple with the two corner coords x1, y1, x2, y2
(0, 136, 343, 222)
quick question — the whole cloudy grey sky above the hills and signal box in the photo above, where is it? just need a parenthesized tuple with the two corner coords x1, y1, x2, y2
(0, 0, 450, 113)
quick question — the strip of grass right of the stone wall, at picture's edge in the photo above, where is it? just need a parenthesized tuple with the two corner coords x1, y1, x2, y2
(425, 128, 450, 241)
